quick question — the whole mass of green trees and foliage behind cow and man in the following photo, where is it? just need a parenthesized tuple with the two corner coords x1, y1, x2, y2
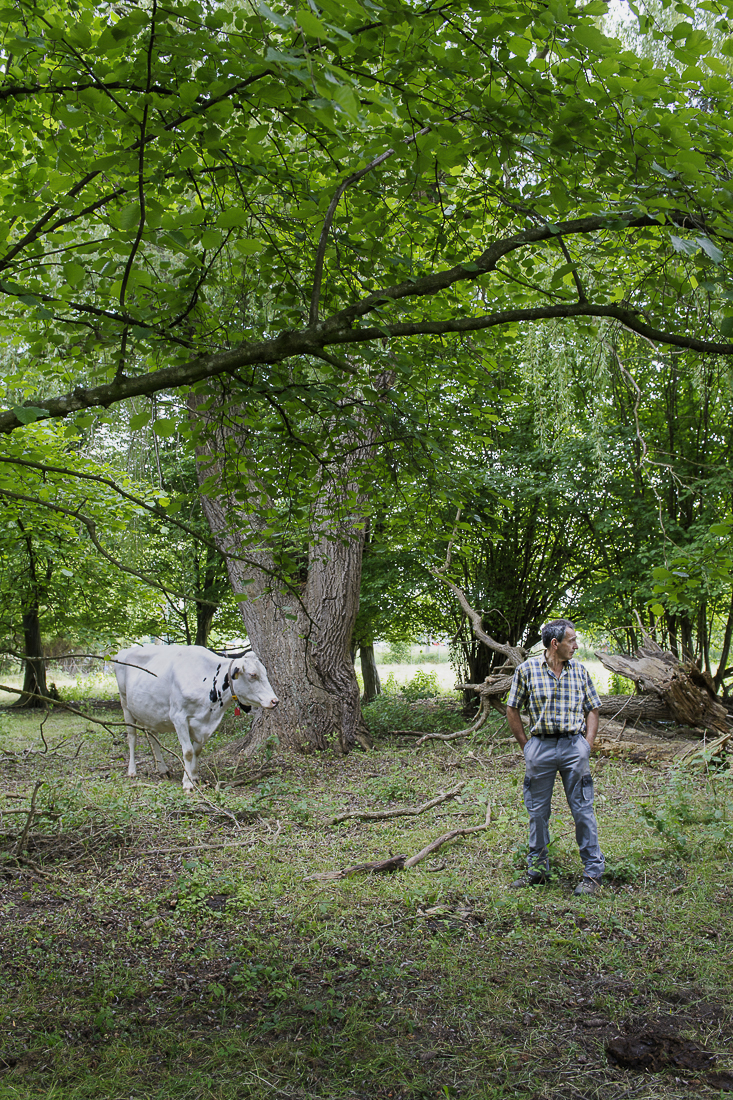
(0, 0, 733, 749)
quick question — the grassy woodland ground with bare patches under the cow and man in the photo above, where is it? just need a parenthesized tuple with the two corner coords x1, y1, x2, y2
(0, 693, 733, 1100)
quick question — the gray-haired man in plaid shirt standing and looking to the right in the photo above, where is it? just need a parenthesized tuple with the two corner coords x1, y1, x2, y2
(506, 619, 604, 894)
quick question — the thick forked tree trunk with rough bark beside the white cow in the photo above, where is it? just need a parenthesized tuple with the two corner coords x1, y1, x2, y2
(192, 393, 371, 755)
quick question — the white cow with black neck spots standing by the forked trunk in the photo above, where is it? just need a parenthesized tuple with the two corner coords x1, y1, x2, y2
(114, 646, 278, 791)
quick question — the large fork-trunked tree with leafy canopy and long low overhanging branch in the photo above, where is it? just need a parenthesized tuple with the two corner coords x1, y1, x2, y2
(0, 0, 733, 747)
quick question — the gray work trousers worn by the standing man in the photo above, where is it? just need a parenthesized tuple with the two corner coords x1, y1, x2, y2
(524, 734, 605, 879)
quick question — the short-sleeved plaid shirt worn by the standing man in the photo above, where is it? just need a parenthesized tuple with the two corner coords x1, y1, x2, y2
(506, 657, 601, 735)
